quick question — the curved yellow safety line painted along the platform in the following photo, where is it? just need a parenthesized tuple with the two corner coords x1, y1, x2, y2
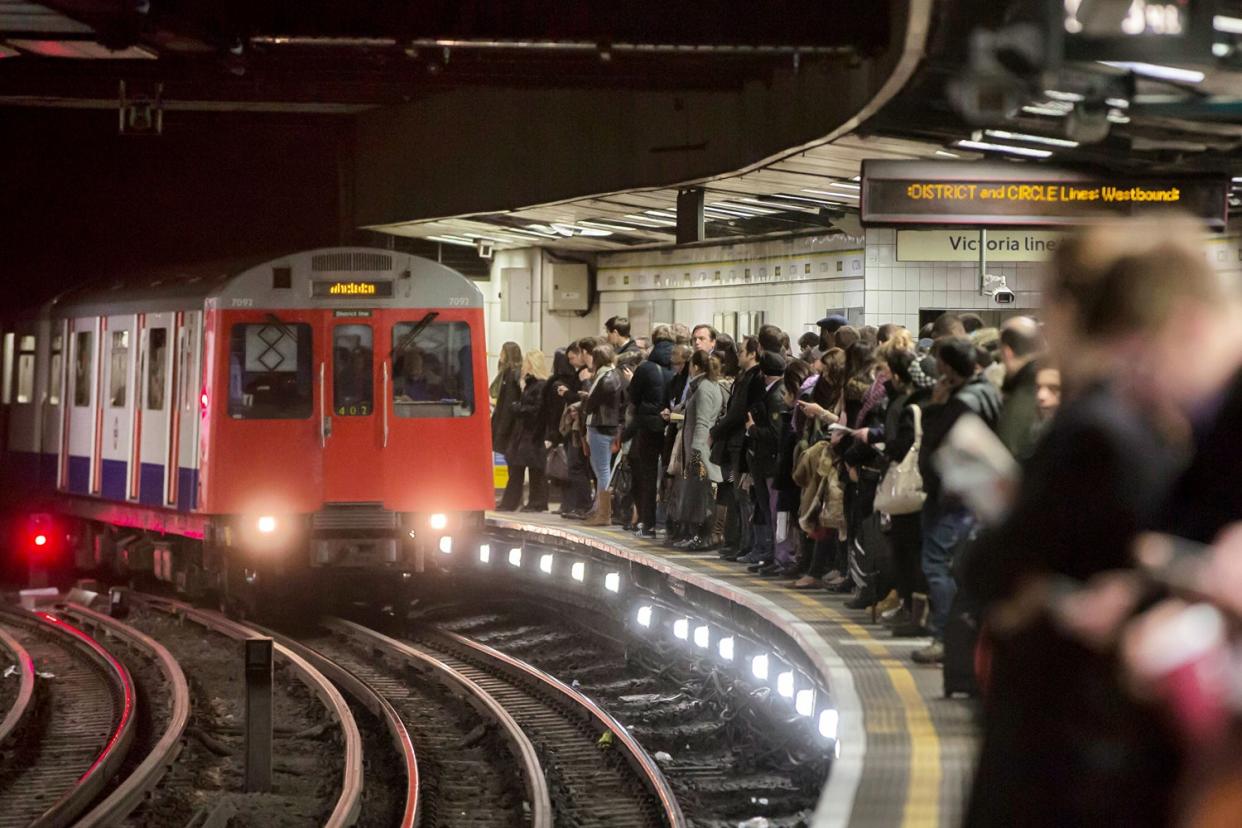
(694, 557, 941, 828)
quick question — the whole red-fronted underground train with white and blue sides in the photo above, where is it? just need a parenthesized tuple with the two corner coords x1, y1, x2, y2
(2, 248, 493, 603)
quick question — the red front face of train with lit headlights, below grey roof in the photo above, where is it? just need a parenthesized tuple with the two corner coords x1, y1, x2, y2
(201, 274, 492, 583)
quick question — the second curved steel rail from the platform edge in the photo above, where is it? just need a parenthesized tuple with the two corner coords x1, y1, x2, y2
(320, 618, 553, 828)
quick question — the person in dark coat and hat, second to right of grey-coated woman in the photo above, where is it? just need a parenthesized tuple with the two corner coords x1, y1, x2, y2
(738, 351, 787, 565)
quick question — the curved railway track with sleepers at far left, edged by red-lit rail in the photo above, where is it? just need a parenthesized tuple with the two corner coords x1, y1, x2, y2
(0, 607, 137, 828)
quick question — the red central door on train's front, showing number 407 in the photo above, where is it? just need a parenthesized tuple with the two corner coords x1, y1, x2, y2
(319, 310, 388, 503)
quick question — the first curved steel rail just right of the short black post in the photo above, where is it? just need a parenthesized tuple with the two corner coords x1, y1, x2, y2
(128, 592, 363, 828)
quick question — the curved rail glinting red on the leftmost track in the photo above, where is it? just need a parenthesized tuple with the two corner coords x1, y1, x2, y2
(0, 606, 137, 827)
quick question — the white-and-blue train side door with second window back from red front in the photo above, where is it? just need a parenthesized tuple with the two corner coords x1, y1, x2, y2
(96, 315, 138, 500)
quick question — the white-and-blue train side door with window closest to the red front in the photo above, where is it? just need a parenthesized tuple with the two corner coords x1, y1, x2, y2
(129, 313, 176, 506)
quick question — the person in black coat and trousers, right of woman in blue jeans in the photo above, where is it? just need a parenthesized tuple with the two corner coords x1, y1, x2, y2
(621, 325, 673, 539)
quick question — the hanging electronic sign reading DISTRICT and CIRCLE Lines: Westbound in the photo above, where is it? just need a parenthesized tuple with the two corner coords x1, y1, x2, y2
(861, 161, 1228, 227)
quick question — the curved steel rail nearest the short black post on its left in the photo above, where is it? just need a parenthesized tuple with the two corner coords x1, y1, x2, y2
(61, 602, 190, 828)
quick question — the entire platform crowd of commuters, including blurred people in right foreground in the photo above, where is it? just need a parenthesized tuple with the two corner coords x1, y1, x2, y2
(493, 220, 1242, 826)
